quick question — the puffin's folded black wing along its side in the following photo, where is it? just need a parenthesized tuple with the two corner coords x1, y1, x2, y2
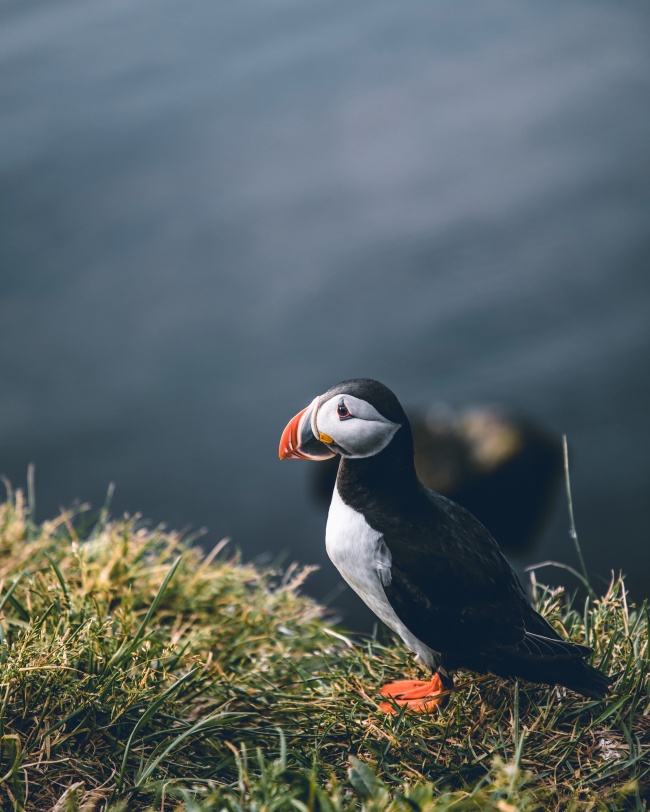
(374, 491, 536, 653)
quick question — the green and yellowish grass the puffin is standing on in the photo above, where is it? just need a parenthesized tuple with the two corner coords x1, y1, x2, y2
(0, 492, 650, 812)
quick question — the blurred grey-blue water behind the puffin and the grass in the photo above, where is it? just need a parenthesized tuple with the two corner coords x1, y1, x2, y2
(0, 0, 650, 626)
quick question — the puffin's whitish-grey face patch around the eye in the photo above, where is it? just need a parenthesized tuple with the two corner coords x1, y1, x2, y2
(311, 392, 400, 457)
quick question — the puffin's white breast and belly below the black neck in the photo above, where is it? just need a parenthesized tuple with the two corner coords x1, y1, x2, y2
(325, 486, 437, 668)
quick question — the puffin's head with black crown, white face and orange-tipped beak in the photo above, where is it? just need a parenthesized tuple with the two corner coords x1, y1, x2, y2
(280, 378, 408, 460)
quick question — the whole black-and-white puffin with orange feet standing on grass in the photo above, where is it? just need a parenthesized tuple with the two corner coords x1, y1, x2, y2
(279, 378, 610, 713)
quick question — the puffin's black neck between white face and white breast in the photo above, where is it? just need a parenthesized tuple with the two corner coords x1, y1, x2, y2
(336, 422, 419, 508)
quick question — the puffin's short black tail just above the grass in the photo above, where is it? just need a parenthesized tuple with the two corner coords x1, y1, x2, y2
(494, 632, 611, 699)
